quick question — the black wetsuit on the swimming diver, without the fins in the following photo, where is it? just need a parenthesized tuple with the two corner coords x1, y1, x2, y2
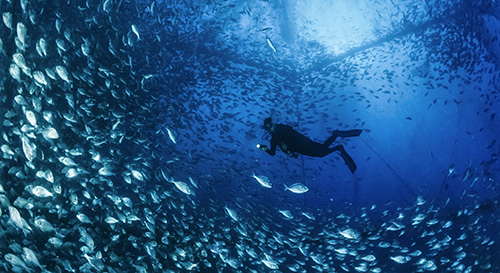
(266, 124, 343, 157)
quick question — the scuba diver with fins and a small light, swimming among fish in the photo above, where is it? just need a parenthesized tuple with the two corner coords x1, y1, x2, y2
(257, 118, 362, 173)
